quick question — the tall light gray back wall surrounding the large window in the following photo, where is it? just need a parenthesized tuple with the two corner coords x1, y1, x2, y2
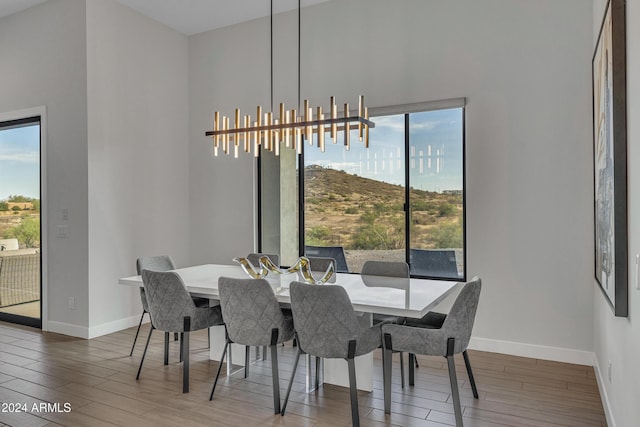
(189, 0, 594, 363)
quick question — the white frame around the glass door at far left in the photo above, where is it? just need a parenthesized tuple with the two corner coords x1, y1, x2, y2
(0, 105, 49, 331)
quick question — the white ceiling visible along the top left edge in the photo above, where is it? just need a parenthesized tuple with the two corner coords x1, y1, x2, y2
(0, 0, 336, 35)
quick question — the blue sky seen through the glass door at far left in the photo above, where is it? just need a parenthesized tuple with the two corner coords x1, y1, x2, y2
(0, 125, 40, 200)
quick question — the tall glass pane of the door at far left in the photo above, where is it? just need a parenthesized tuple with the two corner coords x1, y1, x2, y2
(0, 123, 40, 318)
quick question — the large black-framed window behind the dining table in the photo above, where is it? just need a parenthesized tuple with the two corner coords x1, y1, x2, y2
(261, 100, 466, 279)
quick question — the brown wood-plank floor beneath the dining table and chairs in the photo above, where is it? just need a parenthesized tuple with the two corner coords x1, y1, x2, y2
(0, 322, 606, 427)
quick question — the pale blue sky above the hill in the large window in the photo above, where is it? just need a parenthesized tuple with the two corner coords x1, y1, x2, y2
(305, 108, 463, 192)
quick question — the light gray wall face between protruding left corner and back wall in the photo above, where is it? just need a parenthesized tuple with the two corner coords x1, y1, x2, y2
(87, 0, 191, 336)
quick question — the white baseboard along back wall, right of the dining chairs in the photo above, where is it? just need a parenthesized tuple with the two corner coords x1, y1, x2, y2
(469, 337, 595, 366)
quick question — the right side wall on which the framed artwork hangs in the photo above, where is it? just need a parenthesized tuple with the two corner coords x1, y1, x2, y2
(588, 0, 640, 427)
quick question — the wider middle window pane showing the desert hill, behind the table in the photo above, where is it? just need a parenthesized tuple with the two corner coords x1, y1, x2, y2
(304, 115, 405, 272)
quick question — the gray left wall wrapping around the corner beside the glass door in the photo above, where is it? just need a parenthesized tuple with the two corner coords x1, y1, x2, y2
(0, 0, 190, 337)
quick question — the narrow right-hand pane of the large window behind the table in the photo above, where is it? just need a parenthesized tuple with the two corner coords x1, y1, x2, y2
(409, 108, 464, 278)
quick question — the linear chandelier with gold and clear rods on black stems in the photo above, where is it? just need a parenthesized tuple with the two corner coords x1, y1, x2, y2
(205, 0, 375, 157)
